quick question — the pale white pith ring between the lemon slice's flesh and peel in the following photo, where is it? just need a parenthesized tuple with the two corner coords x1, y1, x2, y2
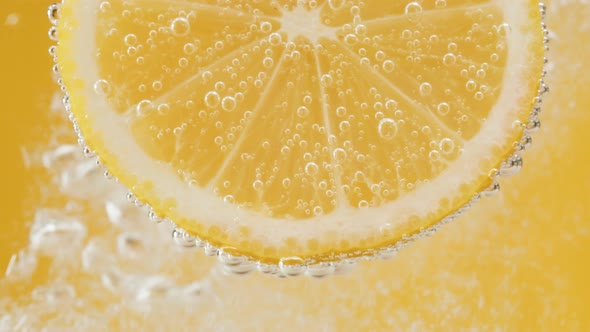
(65, 0, 535, 252)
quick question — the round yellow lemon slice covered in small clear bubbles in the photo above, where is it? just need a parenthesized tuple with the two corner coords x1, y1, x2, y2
(57, 0, 544, 265)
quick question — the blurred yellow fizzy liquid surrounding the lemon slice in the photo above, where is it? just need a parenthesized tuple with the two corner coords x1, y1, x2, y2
(0, 1, 590, 331)
